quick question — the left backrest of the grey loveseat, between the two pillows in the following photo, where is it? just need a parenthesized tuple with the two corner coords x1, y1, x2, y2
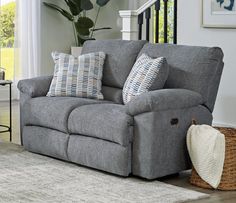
(82, 40, 146, 88)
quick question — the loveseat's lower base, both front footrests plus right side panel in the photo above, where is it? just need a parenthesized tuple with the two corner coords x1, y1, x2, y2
(23, 103, 212, 180)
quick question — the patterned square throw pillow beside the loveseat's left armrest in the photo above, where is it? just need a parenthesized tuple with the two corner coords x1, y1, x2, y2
(47, 52, 106, 99)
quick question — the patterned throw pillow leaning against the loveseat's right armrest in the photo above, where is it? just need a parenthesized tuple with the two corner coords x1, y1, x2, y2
(123, 54, 169, 104)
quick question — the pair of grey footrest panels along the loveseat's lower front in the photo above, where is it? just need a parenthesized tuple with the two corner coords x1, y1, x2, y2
(23, 126, 131, 176)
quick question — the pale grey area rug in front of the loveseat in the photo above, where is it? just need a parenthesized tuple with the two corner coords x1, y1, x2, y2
(0, 143, 208, 203)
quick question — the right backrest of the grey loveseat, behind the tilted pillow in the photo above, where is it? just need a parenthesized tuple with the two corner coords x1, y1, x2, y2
(139, 44, 223, 111)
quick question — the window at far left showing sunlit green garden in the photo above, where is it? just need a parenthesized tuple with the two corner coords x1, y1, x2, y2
(0, 0, 16, 80)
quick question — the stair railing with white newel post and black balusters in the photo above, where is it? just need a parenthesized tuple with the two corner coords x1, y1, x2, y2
(119, 0, 177, 44)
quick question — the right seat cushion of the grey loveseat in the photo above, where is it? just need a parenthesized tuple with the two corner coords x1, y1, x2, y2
(68, 104, 133, 146)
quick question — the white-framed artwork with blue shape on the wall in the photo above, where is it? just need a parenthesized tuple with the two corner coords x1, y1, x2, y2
(202, 0, 236, 28)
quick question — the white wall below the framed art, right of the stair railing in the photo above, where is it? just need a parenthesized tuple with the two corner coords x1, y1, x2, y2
(178, 0, 236, 127)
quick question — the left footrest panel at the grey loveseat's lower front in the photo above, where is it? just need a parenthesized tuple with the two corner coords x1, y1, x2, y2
(23, 126, 69, 160)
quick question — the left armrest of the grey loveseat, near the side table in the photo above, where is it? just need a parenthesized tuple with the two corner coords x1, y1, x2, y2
(17, 76, 52, 98)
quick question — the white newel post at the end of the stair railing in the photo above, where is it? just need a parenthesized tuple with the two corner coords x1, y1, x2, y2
(119, 10, 139, 40)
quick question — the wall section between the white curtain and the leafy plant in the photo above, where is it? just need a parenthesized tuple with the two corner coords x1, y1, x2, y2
(41, 0, 75, 75)
